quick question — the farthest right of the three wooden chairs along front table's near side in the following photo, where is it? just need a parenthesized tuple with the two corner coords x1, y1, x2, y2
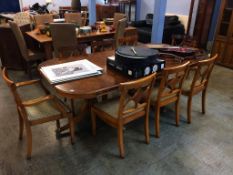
(182, 55, 218, 123)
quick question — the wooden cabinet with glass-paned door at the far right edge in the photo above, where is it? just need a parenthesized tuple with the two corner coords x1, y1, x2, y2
(212, 0, 233, 68)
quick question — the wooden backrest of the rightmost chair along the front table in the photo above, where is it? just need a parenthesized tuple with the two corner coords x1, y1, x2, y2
(187, 54, 218, 94)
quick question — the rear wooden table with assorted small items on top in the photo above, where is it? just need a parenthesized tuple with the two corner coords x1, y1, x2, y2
(26, 26, 137, 60)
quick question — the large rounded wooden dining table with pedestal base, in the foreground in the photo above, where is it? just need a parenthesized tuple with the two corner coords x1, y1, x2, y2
(38, 45, 208, 131)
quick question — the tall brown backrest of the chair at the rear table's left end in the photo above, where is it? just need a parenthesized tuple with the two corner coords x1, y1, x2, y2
(9, 21, 28, 60)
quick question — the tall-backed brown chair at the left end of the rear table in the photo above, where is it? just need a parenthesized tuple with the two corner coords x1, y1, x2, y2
(9, 21, 45, 78)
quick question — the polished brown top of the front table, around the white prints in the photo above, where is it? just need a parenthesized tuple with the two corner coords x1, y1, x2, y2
(40, 51, 130, 99)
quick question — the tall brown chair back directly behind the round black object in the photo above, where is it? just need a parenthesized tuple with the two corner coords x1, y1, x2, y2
(114, 18, 127, 48)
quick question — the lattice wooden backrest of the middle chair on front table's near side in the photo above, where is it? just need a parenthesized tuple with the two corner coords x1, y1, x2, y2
(157, 61, 189, 106)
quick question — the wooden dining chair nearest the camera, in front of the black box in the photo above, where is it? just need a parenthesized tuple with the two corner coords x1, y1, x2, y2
(91, 74, 155, 158)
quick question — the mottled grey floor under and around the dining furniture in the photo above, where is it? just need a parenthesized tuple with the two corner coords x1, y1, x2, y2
(0, 66, 233, 175)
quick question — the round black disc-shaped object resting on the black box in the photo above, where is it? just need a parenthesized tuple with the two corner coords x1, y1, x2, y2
(115, 46, 159, 68)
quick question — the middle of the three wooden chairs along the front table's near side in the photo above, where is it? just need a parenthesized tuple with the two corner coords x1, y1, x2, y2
(151, 61, 189, 138)
